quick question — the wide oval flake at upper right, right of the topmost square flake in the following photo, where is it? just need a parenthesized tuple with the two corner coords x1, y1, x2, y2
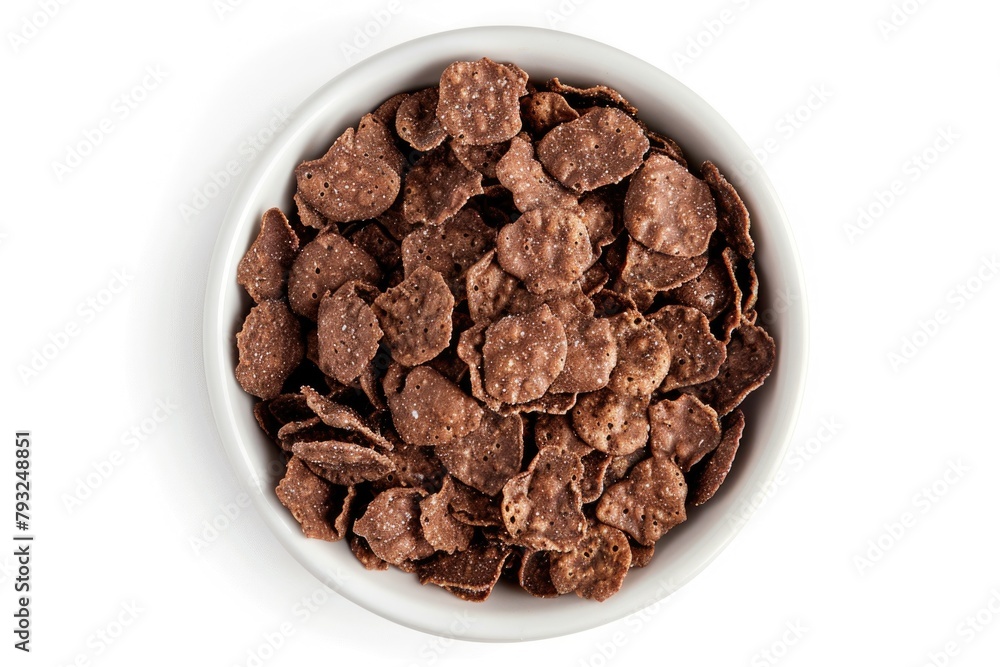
(538, 108, 649, 192)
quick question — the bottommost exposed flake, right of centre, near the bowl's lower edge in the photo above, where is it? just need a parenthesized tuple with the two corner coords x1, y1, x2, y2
(550, 521, 632, 602)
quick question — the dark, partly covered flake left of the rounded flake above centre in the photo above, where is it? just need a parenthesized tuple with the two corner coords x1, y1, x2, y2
(403, 208, 496, 299)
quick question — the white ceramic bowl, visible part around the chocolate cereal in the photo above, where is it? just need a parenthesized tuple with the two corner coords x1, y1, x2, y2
(204, 27, 807, 641)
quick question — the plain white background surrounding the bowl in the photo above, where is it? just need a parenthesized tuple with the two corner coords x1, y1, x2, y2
(0, 0, 1000, 666)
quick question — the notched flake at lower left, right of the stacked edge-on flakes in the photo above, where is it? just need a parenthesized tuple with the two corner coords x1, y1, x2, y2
(354, 488, 434, 566)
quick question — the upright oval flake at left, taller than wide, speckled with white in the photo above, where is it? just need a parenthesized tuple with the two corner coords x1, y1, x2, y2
(317, 281, 382, 384)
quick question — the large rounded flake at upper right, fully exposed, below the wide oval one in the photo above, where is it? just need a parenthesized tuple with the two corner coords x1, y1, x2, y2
(624, 154, 716, 257)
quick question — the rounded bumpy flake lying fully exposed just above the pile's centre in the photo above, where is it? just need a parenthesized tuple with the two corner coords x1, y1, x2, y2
(497, 207, 594, 294)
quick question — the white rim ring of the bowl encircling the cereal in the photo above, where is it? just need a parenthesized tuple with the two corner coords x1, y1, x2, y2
(202, 26, 809, 642)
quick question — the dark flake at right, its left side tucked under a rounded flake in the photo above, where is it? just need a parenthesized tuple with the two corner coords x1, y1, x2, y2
(647, 306, 726, 392)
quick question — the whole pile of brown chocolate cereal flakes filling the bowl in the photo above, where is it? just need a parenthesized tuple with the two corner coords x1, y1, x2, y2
(236, 58, 775, 601)
